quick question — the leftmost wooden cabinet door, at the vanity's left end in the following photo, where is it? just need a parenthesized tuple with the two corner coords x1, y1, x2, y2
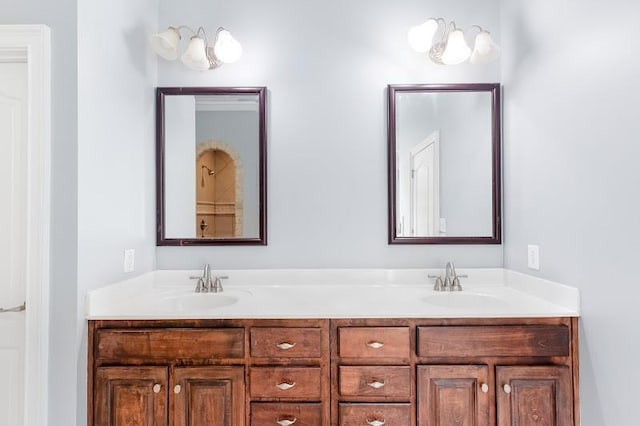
(93, 367, 168, 426)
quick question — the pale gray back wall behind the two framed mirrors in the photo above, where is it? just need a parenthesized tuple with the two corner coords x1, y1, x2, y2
(157, 0, 502, 268)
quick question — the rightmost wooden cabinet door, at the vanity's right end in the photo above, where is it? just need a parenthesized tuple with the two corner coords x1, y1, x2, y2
(496, 366, 573, 426)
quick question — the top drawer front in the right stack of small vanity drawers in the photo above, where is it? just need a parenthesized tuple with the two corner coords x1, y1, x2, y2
(338, 327, 410, 360)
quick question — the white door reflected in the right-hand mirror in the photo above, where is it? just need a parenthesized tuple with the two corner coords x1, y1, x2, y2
(409, 132, 440, 237)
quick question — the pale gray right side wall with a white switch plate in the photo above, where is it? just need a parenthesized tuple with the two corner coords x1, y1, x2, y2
(501, 0, 640, 426)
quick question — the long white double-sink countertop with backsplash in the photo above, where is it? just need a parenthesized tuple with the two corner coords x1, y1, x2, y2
(87, 269, 580, 320)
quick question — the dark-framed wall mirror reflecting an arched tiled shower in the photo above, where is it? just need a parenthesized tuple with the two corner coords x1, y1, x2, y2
(156, 87, 267, 246)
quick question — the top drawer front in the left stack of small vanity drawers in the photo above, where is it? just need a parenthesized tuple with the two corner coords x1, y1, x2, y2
(251, 327, 322, 358)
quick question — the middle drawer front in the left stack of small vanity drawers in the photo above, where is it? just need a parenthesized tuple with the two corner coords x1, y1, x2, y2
(250, 367, 322, 401)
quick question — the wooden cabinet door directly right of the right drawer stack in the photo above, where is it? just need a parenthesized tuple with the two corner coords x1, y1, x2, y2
(417, 365, 490, 426)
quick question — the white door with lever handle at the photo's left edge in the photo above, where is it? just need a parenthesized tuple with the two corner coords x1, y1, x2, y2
(0, 62, 28, 426)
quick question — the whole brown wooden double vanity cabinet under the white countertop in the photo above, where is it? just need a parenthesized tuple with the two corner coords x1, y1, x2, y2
(88, 318, 580, 426)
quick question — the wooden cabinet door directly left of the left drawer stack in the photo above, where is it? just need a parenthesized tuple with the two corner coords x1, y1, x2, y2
(170, 367, 245, 426)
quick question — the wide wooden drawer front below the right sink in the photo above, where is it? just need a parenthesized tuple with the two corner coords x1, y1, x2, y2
(417, 325, 570, 357)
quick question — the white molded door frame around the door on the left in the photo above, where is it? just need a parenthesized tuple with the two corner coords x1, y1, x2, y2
(0, 0, 78, 426)
